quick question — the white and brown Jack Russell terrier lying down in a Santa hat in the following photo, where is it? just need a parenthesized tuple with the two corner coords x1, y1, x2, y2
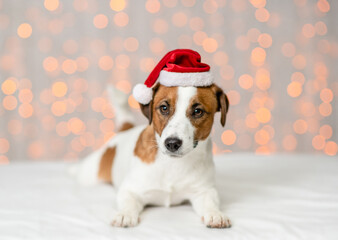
(73, 49, 231, 228)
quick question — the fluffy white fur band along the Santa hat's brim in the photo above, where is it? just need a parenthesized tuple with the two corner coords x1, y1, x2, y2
(158, 70, 214, 87)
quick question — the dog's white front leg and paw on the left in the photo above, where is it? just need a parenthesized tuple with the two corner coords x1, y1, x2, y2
(112, 191, 144, 227)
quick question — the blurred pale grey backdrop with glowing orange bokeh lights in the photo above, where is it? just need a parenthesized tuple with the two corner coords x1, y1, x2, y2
(0, 0, 338, 164)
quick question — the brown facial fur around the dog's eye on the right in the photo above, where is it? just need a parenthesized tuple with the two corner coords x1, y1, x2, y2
(186, 87, 218, 141)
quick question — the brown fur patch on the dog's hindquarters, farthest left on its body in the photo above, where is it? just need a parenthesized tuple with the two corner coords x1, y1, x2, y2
(98, 147, 116, 184)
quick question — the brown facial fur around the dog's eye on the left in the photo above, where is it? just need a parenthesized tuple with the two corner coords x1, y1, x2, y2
(152, 85, 177, 136)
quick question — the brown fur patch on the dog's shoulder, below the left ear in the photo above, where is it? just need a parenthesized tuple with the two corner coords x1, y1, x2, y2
(134, 125, 158, 163)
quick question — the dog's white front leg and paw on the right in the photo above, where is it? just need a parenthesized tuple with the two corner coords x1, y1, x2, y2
(190, 188, 231, 228)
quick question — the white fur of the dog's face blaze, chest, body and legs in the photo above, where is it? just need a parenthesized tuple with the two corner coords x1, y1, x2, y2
(72, 87, 230, 227)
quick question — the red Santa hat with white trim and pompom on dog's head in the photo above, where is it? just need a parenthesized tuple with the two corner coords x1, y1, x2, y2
(133, 49, 213, 105)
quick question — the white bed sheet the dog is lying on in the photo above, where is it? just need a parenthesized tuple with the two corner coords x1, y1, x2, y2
(0, 154, 338, 240)
